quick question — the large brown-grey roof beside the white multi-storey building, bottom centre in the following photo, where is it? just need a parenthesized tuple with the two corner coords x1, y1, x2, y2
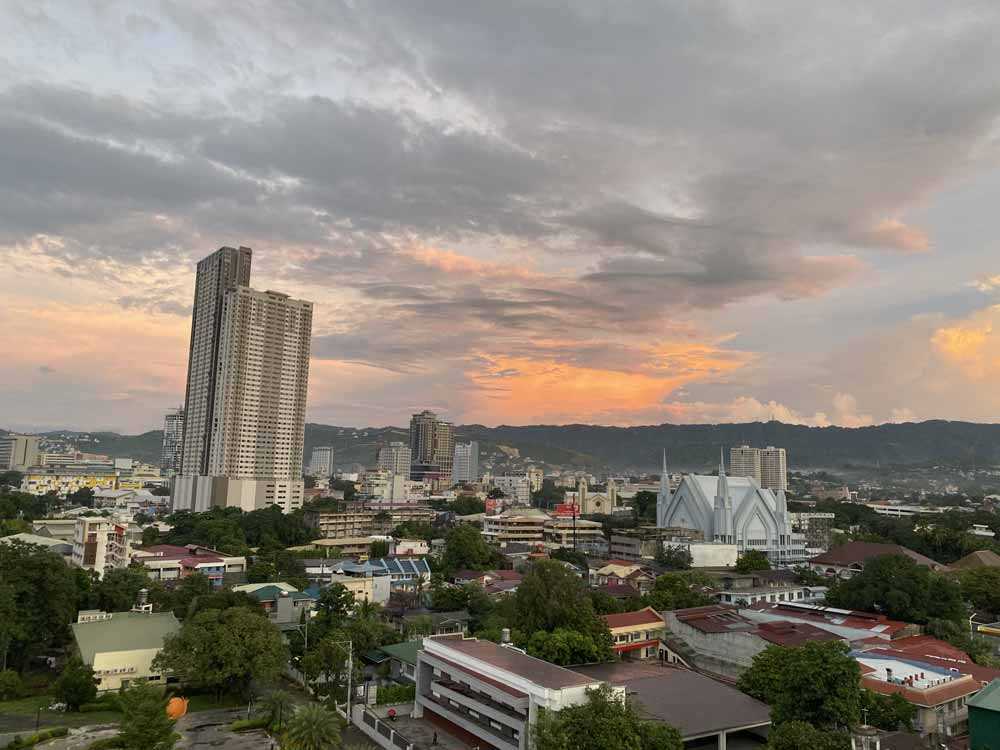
(574, 661, 770, 739)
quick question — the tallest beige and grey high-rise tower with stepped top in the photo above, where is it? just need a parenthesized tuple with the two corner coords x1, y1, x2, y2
(172, 247, 312, 513)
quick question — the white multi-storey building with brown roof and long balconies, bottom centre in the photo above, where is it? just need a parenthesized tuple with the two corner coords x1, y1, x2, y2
(413, 636, 604, 750)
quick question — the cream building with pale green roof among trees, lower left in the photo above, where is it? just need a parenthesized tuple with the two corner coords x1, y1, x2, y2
(71, 610, 181, 693)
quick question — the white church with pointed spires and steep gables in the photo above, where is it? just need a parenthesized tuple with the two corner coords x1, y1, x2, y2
(656, 451, 807, 566)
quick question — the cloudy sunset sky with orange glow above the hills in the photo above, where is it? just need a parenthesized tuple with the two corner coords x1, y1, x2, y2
(0, 0, 1000, 432)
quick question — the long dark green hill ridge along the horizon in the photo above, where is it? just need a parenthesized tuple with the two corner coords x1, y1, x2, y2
(19, 420, 1000, 471)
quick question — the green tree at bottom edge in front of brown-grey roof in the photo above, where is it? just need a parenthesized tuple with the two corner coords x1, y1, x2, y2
(532, 685, 684, 750)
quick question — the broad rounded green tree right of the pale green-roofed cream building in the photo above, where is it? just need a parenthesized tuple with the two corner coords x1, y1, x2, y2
(153, 607, 288, 696)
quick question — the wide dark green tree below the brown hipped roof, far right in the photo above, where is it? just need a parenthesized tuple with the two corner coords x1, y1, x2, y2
(826, 555, 965, 624)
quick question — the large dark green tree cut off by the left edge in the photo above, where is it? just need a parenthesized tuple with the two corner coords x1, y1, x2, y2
(0, 541, 77, 671)
